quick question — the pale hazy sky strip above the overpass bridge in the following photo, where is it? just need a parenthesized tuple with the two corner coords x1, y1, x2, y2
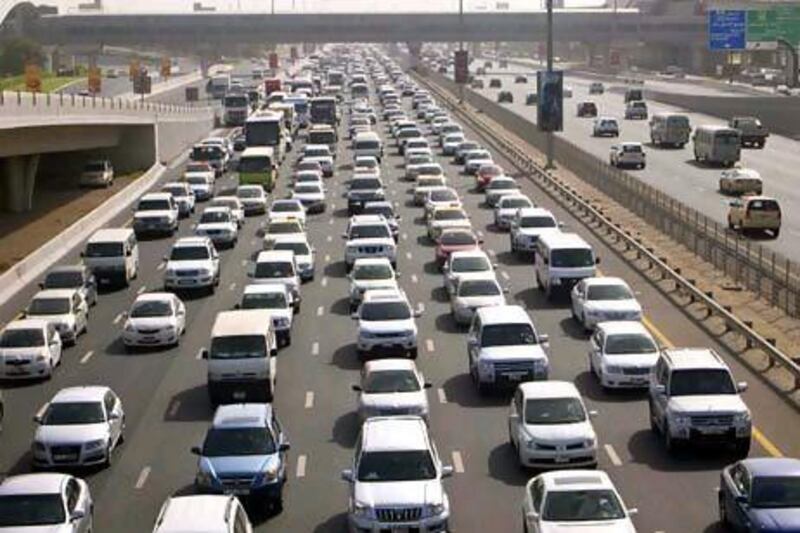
(57, 0, 604, 13)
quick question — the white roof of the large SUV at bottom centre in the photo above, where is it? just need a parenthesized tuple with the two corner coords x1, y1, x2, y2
(361, 416, 428, 451)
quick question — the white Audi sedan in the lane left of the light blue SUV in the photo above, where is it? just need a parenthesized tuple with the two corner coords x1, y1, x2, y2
(31, 386, 125, 468)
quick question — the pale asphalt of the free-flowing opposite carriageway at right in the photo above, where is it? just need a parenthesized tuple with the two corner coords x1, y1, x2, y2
(466, 67, 800, 261)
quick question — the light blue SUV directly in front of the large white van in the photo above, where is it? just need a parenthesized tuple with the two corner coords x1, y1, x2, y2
(192, 403, 289, 512)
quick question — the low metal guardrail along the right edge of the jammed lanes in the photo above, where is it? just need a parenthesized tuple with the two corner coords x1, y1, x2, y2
(417, 68, 800, 388)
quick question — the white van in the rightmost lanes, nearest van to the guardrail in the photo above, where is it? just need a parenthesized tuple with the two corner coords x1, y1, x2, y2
(533, 231, 600, 299)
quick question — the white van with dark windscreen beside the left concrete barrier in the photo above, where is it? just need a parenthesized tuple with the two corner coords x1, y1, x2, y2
(81, 228, 139, 287)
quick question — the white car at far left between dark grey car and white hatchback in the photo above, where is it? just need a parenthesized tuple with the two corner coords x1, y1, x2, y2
(25, 289, 89, 345)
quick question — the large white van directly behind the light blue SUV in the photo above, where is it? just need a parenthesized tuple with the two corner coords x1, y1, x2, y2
(202, 309, 278, 405)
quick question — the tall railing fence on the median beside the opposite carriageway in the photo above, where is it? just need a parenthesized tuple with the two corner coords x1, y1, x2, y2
(426, 66, 800, 317)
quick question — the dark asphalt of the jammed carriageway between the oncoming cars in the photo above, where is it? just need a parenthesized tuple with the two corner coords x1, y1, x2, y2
(0, 63, 800, 533)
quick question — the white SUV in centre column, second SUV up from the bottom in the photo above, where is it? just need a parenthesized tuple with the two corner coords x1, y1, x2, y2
(352, 288, 420, 359)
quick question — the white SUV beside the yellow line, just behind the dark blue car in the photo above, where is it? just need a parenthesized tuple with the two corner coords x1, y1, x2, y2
(648, 348, 752, 457)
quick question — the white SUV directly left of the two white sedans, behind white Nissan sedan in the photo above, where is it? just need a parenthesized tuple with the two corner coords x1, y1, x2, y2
(467, 305, 550, 394)
